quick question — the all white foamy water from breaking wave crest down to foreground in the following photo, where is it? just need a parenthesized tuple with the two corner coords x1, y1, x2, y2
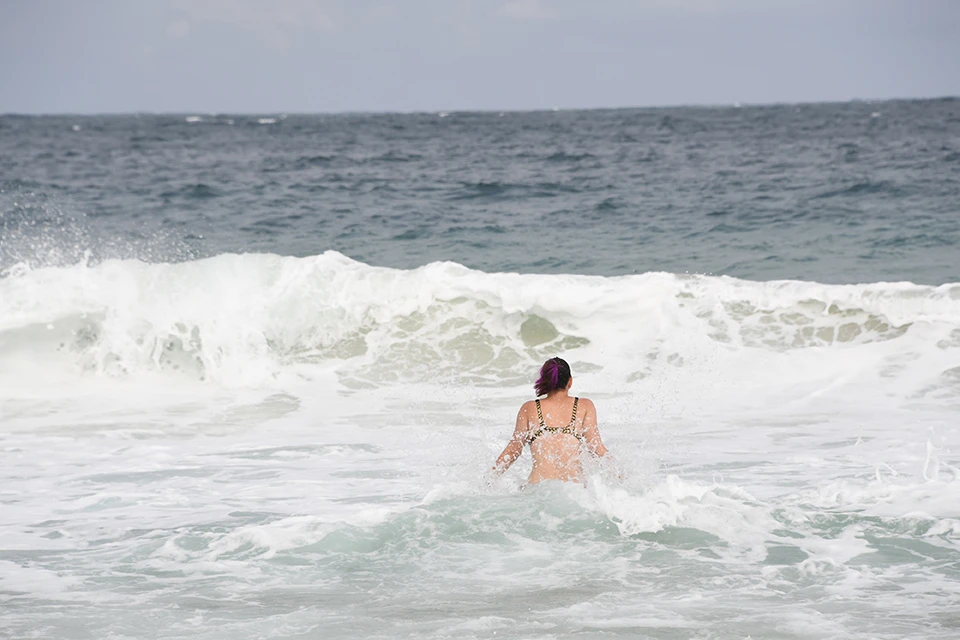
(0, 252, 960, 639)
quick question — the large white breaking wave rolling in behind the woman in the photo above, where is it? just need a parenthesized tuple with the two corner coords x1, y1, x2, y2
(0, 252, 960, 393)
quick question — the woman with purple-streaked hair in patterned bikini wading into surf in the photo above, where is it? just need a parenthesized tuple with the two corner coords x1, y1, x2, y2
(493, 358, 607, 483)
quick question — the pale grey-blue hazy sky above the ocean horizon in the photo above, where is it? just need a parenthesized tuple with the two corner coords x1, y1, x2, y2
(0, 0, 960, 113)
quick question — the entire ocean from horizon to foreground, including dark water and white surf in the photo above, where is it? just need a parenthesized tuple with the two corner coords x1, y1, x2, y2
(0, 99, 960, 640)
